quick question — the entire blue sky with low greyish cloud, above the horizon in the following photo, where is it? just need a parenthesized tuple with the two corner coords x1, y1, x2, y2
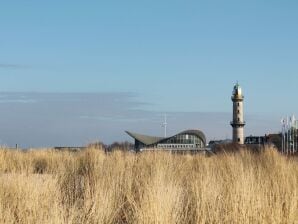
(0, 0, 298, 147)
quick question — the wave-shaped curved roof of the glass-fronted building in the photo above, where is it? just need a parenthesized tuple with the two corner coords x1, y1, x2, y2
(126, 130, 206, 145)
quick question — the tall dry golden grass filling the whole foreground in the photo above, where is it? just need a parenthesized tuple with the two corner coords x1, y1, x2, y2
(0, 149, 298, 224)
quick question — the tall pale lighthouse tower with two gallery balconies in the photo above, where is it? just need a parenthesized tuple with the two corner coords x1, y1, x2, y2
(231, 82, 245, 145)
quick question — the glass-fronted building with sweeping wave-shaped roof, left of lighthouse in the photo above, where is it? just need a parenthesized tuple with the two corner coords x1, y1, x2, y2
(126, 130, 206, 152)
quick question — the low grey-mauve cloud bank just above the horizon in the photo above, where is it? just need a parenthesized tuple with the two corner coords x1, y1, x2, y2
(0, 92, 279, 148)
